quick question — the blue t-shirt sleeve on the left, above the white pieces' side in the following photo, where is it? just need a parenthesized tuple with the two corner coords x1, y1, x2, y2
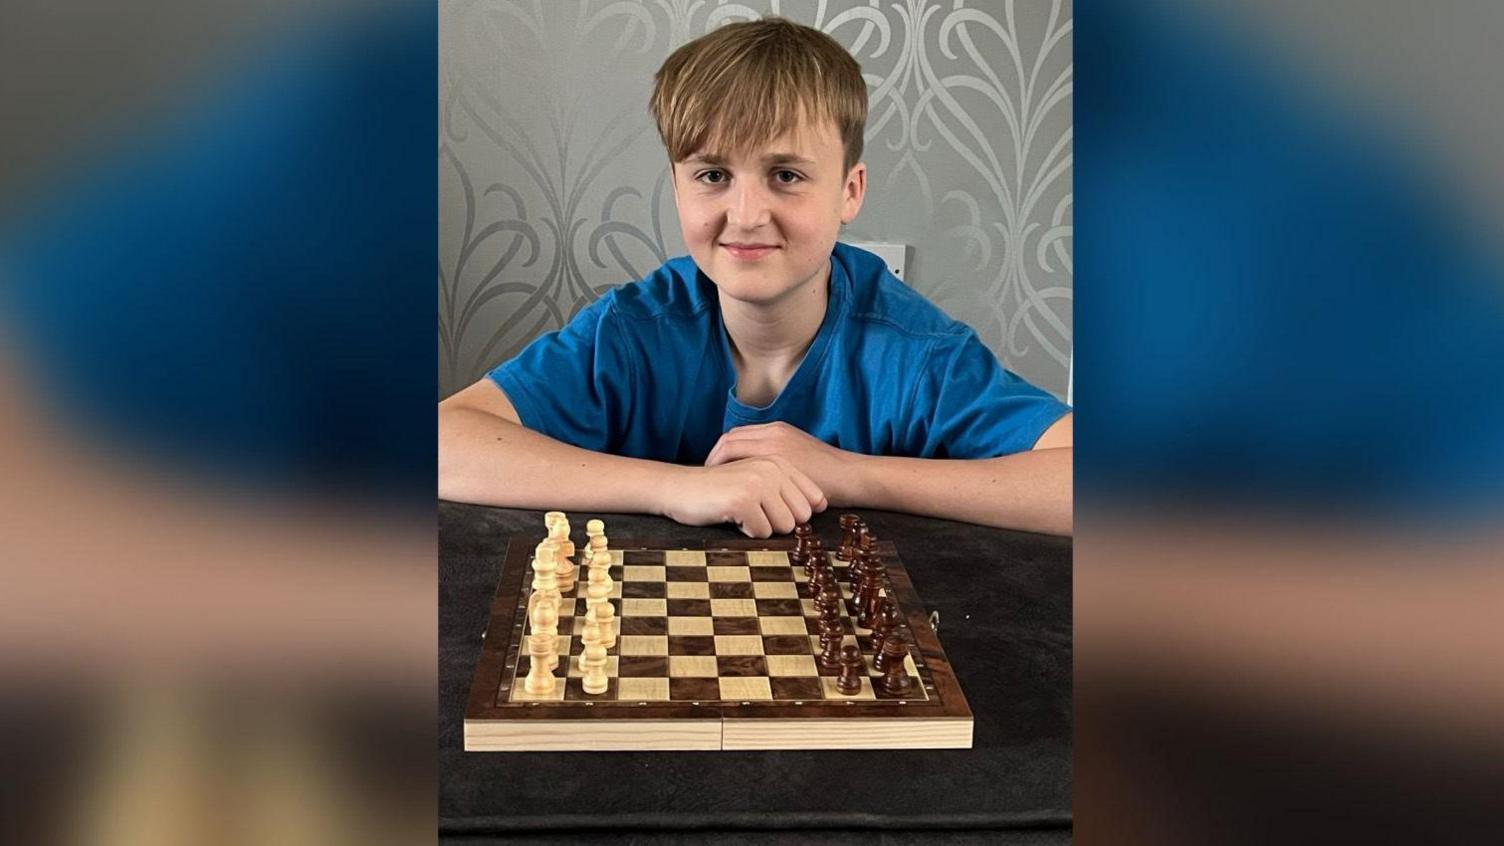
(490, 292, 635, 453)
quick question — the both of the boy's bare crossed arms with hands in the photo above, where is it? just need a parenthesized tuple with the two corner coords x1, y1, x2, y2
(439, 379, 1072, 537)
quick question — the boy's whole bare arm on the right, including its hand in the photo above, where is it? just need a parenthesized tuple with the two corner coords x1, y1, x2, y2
(705, 414, 1074, 534)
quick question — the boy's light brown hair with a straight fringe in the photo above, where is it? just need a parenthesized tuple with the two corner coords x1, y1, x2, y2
(650, 18, 866, 172)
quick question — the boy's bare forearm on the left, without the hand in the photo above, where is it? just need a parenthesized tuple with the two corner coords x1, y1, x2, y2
(439, 408, 681, 513)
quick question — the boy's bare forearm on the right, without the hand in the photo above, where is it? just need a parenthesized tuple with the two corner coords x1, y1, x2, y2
(844, 447, 1074, 534)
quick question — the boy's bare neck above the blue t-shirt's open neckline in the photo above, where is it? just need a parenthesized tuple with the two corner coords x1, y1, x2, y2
(720, 262, 830, 405)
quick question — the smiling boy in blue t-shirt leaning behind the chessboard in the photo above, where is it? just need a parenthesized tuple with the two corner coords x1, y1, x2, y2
(439, 18, 1072, 537)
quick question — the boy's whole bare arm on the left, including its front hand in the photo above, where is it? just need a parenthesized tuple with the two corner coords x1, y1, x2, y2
(439, 378, 826, 537)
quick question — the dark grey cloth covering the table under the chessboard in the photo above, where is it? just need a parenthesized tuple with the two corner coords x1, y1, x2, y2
(439, 503, 1071, 843)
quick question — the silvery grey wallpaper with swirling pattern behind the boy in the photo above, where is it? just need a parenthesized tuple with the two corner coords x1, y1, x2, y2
(439, 0, 1072, 397)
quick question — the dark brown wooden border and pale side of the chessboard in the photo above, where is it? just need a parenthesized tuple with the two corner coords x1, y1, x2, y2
(465, 537, 972, 751)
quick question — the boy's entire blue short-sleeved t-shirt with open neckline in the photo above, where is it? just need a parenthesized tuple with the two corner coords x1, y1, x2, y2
(490, 244, 1069, 464)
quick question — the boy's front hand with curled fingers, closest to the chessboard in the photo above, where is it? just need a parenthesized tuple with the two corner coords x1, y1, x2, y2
(663, 456, 829, 537)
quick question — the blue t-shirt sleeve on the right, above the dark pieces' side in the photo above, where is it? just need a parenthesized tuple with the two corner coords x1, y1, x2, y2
(905, 333, 1071, 459)
